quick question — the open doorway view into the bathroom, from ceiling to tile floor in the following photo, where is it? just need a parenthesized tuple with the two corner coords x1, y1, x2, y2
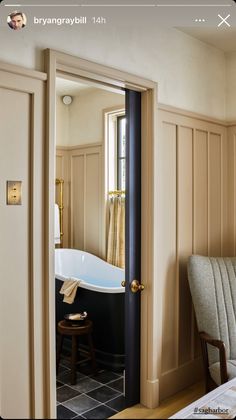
(55, 77, 126, 418)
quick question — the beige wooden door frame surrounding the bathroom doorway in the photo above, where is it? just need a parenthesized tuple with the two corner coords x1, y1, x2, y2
(45, 49, 159, 418)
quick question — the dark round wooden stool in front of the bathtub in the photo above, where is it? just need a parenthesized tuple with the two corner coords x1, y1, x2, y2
(57, 320, 96, 385)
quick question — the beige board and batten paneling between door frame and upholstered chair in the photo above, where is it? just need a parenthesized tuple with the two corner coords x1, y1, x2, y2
(157, 109, 230, 399)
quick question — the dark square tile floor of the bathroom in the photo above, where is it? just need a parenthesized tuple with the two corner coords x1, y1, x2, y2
(57, 358, 125, 419)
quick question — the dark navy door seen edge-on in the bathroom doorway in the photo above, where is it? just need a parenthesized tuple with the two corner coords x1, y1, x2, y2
(125, 90, 141, 407)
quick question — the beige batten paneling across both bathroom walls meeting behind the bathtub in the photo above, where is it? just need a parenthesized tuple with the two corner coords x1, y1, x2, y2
(56, 143, 105, 258)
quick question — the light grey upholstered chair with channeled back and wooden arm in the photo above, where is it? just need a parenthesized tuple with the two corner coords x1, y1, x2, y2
(188, 255, 236, 392)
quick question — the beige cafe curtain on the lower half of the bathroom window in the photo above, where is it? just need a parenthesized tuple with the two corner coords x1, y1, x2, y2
(107, 196, 125, 268)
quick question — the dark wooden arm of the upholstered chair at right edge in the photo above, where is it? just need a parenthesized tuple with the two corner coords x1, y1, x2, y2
(200, 332, 228, 384)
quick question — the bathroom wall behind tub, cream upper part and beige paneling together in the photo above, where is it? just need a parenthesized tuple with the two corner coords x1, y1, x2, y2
(56, 88, 125, 259)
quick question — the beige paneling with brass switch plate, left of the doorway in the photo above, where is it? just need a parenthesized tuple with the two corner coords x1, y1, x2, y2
(0, 67, 48, 418)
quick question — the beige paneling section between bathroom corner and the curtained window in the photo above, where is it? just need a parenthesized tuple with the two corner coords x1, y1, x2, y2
(70, 145, 104, 256)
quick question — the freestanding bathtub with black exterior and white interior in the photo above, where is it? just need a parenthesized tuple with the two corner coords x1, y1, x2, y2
(55, 248, 125, 370)
